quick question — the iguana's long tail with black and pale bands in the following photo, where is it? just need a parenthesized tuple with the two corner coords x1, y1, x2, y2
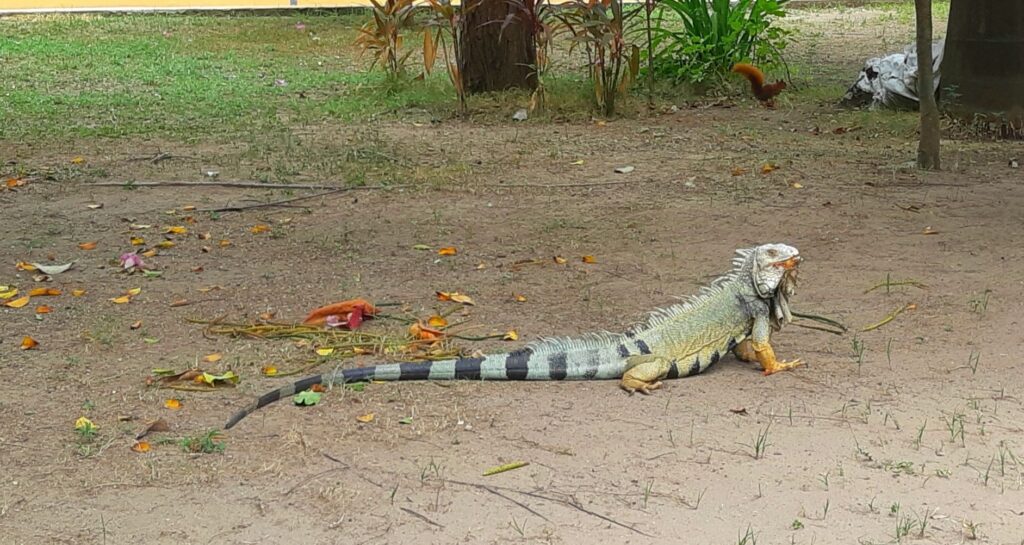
(224, 347, 628, 429)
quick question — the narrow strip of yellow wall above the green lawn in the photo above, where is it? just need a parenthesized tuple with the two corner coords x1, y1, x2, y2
(0, 0, 385, 12)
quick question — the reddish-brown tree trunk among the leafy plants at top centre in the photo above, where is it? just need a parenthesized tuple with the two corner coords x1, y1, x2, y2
(462, 0, 537, 93)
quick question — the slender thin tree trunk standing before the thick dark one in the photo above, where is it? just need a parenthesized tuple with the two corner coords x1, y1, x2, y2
(913, 0, 939, 170)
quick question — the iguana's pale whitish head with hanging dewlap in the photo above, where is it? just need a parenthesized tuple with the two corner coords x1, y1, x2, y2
(748, 244, 803, 330)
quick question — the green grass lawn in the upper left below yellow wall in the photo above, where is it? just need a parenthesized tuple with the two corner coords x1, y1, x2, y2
(0, 14, 453, 140)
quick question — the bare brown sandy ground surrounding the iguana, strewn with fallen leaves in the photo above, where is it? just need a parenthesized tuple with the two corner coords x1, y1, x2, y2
(0, 4, 1024, 544)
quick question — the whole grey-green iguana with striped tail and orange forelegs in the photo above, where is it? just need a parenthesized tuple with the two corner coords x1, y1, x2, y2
(224, 244, 802, 429)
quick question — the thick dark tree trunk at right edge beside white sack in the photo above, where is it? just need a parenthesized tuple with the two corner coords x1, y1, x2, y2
(942, 0, 1024, 137)
